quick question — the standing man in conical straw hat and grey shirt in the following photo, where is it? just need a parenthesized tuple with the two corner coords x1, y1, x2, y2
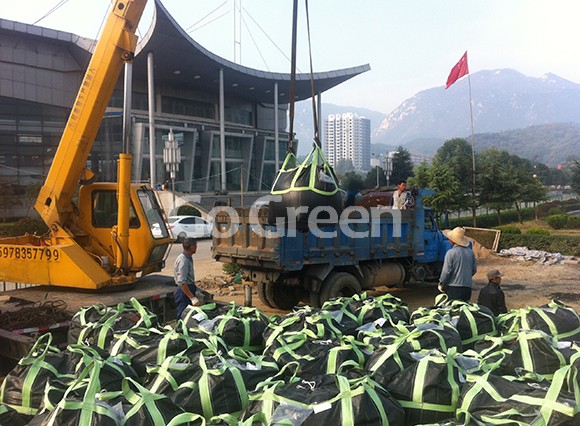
(439, 226, 477, 302)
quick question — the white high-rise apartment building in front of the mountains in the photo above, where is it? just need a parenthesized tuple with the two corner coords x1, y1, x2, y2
(324, 112, 371, 170)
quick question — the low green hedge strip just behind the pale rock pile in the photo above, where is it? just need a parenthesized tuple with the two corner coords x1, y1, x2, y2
(499, 234, 580, 256)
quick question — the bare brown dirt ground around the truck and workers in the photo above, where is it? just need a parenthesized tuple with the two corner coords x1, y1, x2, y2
(198, 243, 580, 315)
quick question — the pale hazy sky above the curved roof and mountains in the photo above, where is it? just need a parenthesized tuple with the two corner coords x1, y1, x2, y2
(0, 0, 580, 113)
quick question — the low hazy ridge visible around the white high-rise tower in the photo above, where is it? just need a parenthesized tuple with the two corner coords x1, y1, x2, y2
(294, 100, 390, 155)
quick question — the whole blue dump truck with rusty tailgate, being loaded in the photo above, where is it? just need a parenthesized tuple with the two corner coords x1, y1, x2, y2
(213, 189, 451, 310)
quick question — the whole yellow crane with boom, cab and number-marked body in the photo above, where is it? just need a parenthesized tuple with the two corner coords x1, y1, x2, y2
(0, 0, 171, 289)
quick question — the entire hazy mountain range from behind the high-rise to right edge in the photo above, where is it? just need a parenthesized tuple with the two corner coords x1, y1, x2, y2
(294, 69, 580, 166)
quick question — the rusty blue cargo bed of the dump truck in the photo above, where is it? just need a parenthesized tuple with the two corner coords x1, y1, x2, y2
(213, 209, 423, 271)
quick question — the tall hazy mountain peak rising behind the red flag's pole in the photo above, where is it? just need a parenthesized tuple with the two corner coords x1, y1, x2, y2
(375, 69, 580, 145)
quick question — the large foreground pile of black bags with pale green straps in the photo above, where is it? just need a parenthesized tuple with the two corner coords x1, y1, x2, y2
(0, 294, 580, 426)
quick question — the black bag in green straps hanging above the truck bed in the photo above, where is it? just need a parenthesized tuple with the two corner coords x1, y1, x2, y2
(268, 144, 343, 229)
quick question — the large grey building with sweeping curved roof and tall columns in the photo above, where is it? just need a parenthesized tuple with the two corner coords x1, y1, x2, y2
(0, 0, 370, 213)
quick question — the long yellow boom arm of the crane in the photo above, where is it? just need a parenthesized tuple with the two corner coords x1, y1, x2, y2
(34, 0, 147, 227)
